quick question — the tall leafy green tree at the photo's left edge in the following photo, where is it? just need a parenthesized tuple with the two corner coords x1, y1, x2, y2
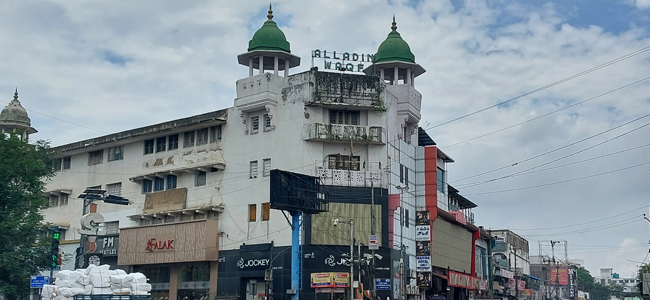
(0, 134, 53, 300)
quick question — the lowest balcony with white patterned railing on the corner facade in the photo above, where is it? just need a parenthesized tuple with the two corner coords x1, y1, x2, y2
(316, 169, 382, 187)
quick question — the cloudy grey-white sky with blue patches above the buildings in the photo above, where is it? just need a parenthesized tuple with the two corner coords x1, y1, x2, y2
(0, 0, 650, 276)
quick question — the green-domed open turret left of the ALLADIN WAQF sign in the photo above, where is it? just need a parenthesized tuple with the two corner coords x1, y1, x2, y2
(237, 4, 300, 77)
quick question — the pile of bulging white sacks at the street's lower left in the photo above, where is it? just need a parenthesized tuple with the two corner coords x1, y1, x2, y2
(41, 265, 151, 300)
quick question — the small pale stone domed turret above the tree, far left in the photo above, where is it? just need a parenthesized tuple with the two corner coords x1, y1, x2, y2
(0, 88, 37, 141)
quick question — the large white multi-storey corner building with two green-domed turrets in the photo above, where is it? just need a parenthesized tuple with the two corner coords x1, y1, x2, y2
(25, 9, 485, 300)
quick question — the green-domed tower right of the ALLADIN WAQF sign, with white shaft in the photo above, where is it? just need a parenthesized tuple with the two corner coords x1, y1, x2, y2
(363, 16, 425, 142)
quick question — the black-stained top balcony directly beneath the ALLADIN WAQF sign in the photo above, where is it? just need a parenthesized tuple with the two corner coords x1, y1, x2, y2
(305, 72, 386, 110)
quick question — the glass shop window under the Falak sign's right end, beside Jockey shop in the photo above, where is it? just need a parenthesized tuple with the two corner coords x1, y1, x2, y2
(178, 262, 210, 300)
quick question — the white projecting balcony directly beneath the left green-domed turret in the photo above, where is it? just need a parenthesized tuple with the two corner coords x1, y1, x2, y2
(235, 73, 285, 112)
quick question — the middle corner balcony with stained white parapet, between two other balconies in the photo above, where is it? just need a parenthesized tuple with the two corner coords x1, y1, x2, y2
(305, 123, 385, 144)
